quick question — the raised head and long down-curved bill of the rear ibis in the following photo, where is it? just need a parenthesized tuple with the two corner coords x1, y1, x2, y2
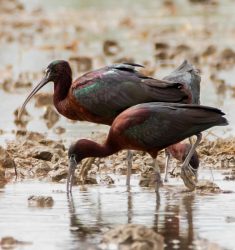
(18, 60, 72, 119)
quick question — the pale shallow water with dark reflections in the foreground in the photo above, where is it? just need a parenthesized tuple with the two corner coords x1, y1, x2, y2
(0, 171, 235, 250)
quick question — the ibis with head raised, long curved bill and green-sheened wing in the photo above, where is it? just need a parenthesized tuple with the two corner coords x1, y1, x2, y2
(19, 60, 200, 188)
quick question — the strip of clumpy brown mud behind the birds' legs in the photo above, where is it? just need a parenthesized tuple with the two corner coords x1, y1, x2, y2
(0, 130, 235, 189)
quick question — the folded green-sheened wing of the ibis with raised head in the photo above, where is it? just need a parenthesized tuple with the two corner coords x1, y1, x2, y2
(73, 64, 189, 117)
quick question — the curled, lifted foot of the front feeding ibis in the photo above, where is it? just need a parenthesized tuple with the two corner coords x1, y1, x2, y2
(180, 164, 197, 191)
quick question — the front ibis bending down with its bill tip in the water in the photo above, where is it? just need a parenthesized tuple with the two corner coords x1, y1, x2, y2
(67, 102, 227, 192)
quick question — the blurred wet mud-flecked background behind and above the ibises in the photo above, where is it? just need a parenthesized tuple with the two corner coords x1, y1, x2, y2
(0, 0, 235, 145)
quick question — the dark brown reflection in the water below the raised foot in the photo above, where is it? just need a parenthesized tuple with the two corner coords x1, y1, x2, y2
(153, 192, 195, 250)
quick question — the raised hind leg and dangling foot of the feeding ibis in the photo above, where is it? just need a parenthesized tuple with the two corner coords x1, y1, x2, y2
(180, 133, 202, 190)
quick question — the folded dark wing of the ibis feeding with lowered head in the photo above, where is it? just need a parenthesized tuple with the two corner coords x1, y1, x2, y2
(116, 103, 227, 149)
